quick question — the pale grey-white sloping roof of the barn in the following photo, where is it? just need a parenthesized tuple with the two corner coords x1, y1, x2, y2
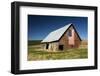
(42, 23, 71, 43)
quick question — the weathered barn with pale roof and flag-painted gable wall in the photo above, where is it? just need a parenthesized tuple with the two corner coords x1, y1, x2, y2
(41, 23, 81, 51)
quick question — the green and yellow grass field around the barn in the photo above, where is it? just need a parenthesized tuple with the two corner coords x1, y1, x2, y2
(28, 41, 88, 61)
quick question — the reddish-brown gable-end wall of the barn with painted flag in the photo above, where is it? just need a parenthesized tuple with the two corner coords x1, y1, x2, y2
(59, 27, 81, 49)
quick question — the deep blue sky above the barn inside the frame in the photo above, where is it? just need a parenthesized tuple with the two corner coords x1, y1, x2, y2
(28, 15, 88, 40)
